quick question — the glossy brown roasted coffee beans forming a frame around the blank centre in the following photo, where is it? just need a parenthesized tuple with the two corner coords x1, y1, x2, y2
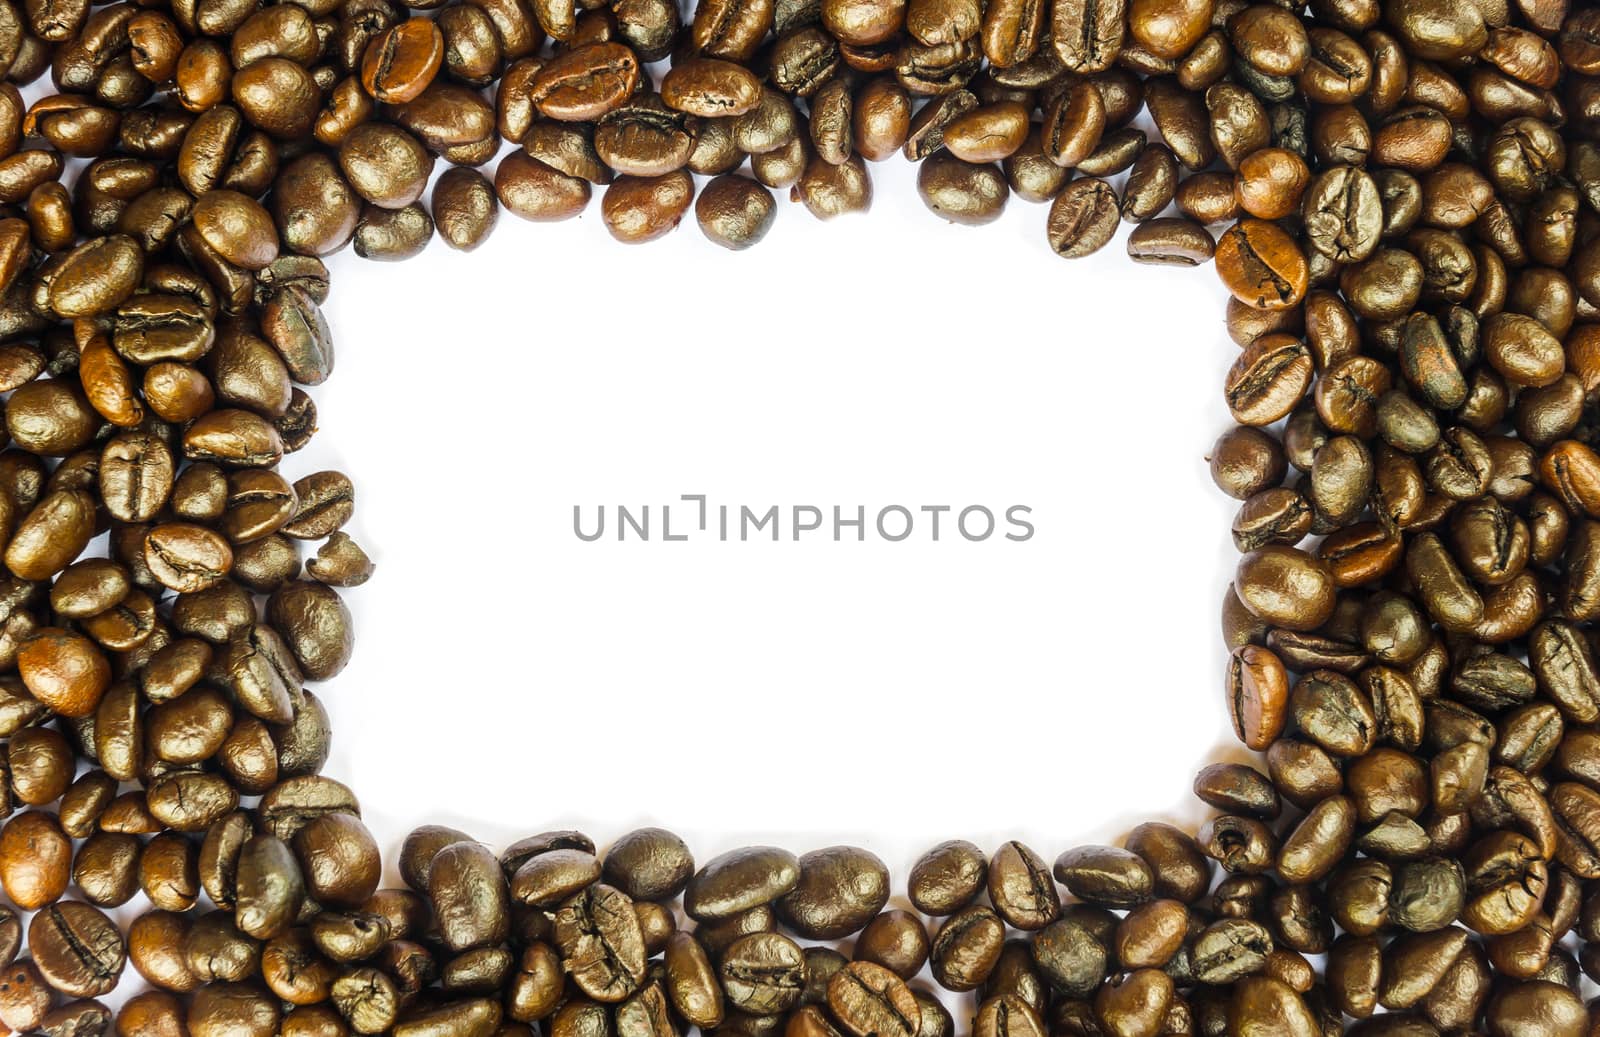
(0, 0, 1600, 1037)
